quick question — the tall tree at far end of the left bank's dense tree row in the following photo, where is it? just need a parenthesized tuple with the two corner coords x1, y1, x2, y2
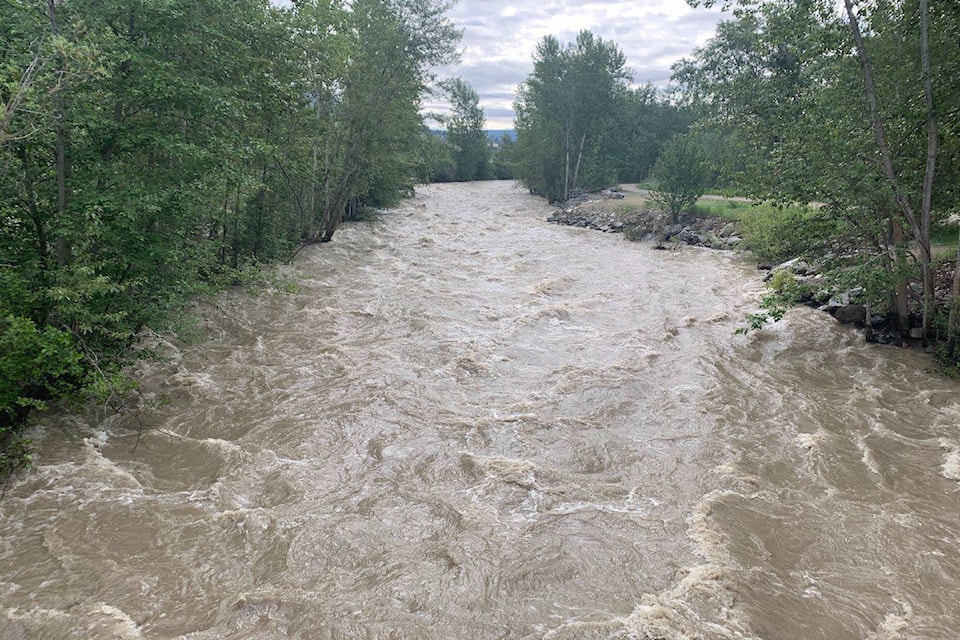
(319, 0, 460, 242)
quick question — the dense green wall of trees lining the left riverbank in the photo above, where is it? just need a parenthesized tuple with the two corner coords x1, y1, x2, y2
(0, 0, 459, 472)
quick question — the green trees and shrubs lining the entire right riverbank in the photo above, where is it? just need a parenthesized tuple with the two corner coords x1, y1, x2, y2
(516, 0, 960, 370)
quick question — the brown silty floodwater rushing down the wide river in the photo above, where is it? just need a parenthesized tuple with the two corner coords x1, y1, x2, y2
(0, 183, 960, 640)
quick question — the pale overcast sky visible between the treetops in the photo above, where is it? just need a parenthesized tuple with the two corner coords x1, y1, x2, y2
(424, 0, 721, 129)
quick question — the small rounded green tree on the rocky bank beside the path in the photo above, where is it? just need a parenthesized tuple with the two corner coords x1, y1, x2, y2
(650, 136, 711, 224)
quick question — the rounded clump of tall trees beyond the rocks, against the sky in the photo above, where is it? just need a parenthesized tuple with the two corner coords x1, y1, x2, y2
(511, 31, 689, 201)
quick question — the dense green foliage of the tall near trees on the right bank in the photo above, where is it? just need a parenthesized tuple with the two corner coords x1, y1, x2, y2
(675, 0, 960, 350)
